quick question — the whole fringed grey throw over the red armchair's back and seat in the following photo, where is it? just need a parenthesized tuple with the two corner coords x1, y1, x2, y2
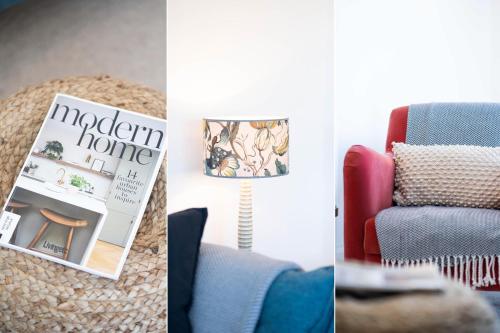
(376, 103, 500, 287)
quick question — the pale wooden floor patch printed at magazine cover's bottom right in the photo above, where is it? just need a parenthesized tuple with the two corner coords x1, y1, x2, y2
(87, 240, 125, 274)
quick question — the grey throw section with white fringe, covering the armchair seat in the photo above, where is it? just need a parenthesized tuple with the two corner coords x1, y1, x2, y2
(375, 206, 500, 288)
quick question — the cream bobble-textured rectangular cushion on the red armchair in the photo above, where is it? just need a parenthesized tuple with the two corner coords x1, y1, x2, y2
(393, 143, 500, 208)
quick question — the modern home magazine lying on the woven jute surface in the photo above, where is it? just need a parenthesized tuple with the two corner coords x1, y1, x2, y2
(0, 94, 167, 280)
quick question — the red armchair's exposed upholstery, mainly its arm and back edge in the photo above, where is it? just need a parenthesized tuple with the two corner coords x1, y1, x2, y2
(344, 106, 500, 290)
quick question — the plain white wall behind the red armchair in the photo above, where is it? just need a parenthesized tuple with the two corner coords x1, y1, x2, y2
(334, 0, 500, 257)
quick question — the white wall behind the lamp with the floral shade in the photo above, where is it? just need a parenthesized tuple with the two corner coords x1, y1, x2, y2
(167, 0, 334, 268)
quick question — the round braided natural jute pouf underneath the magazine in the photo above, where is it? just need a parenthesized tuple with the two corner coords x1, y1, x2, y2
(0, 76, 167, 332)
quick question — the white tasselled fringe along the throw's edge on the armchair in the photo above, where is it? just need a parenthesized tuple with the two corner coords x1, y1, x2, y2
(382, 255, 500, 289)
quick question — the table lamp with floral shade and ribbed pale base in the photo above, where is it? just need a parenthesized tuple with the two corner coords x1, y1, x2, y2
(203, 117, 288, 251)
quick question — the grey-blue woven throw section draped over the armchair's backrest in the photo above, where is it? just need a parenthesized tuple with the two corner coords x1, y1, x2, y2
(406, 103, 500, 147)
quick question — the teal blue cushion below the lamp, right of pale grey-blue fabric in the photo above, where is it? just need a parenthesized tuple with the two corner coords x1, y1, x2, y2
(256, 267, 334, 333)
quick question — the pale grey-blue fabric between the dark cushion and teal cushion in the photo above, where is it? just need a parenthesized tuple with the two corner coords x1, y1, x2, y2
(189, 244, 299, 333)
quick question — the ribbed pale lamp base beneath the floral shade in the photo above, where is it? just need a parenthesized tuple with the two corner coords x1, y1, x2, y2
(238, 179, 253, 251)
